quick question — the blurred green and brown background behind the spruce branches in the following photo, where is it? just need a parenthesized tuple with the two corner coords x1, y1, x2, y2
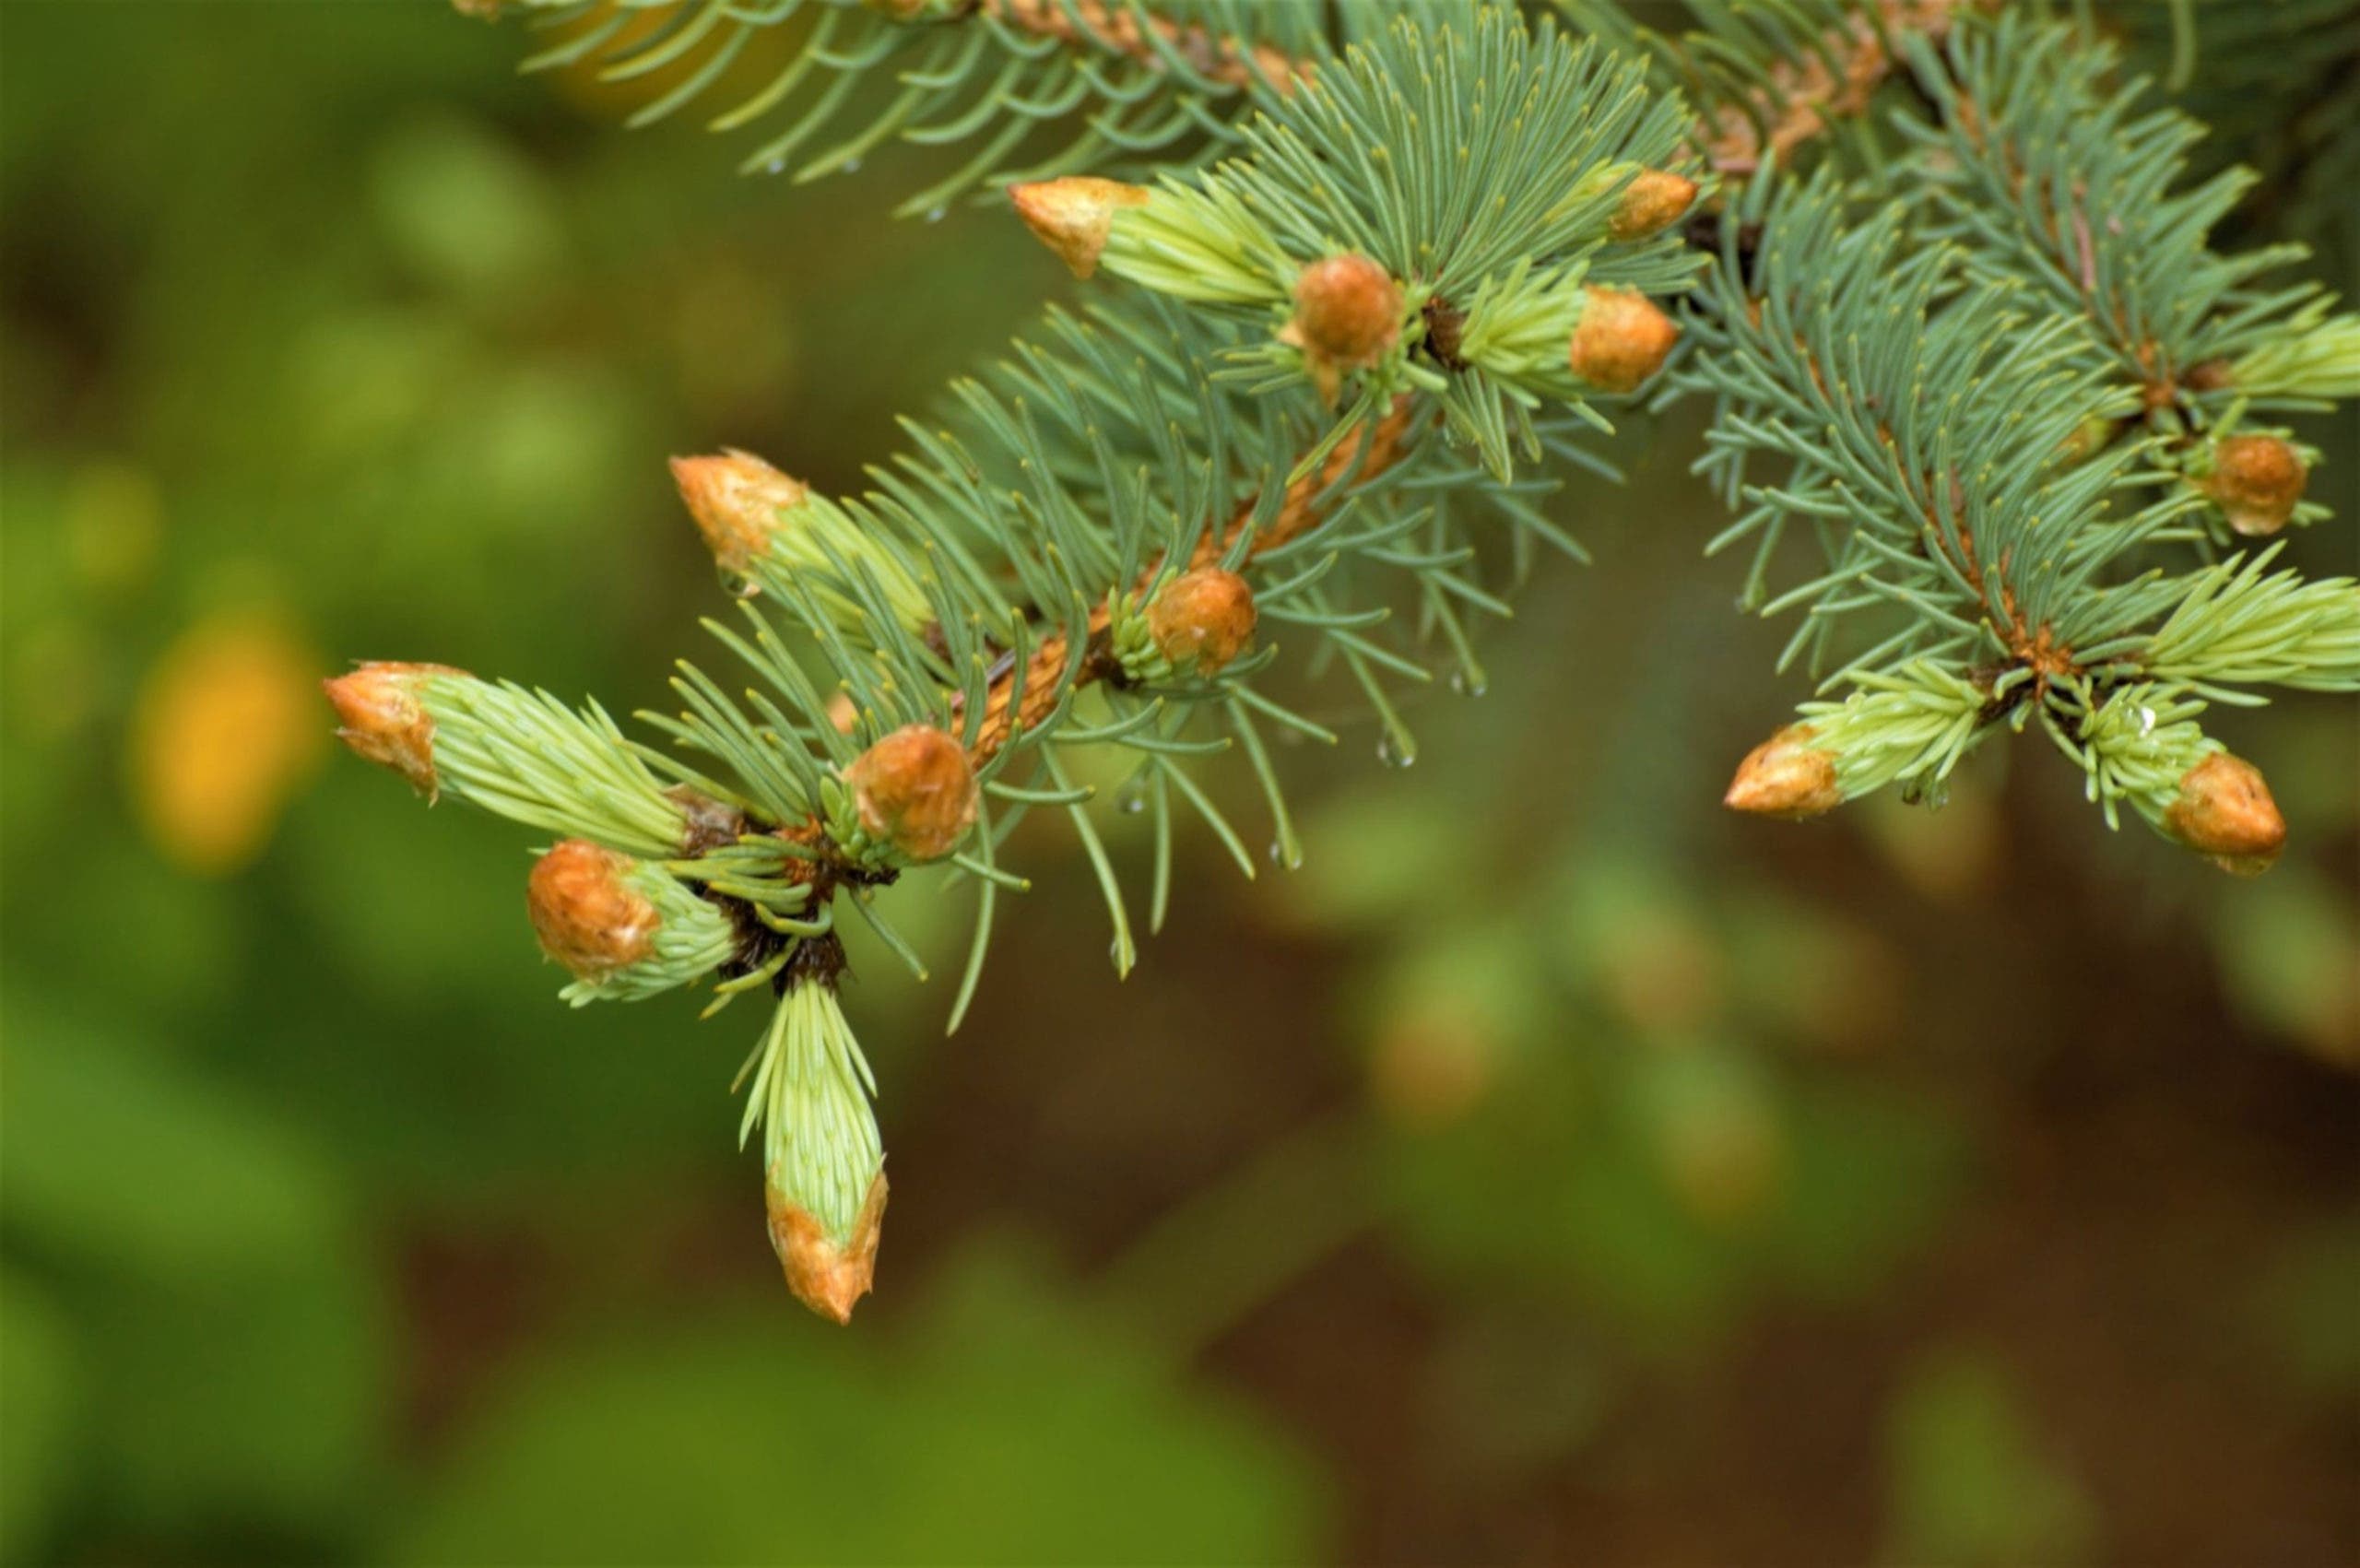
(0, 0, 2360, 1563)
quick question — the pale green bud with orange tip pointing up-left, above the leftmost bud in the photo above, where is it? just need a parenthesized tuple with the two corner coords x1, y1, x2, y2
(673, 449, 935, 633)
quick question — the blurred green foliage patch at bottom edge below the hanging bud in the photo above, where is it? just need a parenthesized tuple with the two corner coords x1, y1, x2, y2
(395, 1256, 1316, 1563)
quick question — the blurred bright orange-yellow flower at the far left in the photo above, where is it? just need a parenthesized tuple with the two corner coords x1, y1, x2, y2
(130, 611, 328, 876)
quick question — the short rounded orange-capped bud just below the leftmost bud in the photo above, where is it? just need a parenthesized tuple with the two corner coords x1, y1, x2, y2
(524, 838, 737, 1006)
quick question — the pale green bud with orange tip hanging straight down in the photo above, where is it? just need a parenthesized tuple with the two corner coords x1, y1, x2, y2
(738, 968, 885, 1323)
